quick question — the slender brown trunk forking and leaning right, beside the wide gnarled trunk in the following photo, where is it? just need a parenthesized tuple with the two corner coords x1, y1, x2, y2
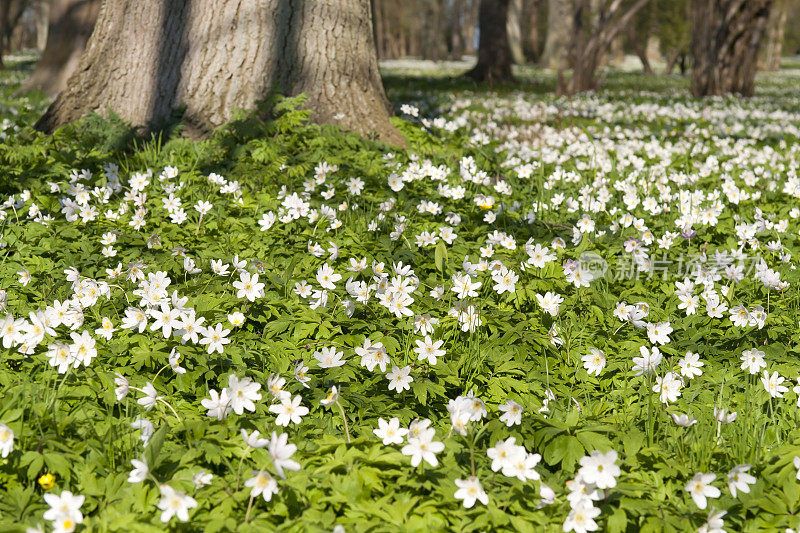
(557, 0, 649, 94)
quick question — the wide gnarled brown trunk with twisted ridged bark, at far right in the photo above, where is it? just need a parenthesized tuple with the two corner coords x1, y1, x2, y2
(692, 0, 773, 96)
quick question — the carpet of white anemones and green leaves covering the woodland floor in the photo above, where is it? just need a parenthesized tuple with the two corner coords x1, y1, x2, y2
(0, 57, 800, 532)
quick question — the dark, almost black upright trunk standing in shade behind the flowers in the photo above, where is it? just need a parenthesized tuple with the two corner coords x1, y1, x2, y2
(466, 0, 514, 83)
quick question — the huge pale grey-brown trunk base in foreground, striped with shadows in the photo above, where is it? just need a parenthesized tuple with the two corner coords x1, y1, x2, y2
(37, 0, 404, 144)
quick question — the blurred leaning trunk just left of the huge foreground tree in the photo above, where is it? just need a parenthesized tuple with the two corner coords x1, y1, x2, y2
(20, 0, 101, 96)
